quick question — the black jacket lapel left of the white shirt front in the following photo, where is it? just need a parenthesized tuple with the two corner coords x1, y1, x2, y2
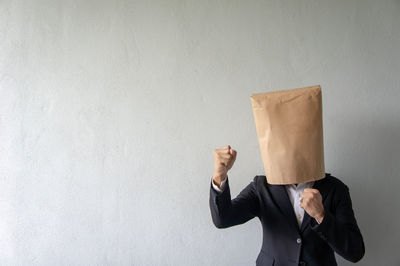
(270, 185, 299, 230)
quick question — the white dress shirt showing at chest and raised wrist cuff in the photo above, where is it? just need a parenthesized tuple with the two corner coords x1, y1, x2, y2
(211, 178, 319, 228)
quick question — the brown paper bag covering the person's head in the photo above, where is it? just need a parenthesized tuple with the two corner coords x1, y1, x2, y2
(251, 85, 325, 184)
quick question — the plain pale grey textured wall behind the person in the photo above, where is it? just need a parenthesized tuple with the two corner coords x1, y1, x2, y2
(0, 0, 400, 265)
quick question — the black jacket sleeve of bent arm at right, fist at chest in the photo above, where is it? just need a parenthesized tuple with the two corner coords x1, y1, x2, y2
(311, 184, 365, 262)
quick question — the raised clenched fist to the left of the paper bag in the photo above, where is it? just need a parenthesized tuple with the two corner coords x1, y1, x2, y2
(213, 145, 236, 187)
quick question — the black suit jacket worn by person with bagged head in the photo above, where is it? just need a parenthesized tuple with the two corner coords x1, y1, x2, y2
(210, 173, 365, 266)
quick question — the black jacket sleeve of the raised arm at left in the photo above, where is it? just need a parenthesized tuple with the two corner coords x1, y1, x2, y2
(210, 177, 259, 228)
